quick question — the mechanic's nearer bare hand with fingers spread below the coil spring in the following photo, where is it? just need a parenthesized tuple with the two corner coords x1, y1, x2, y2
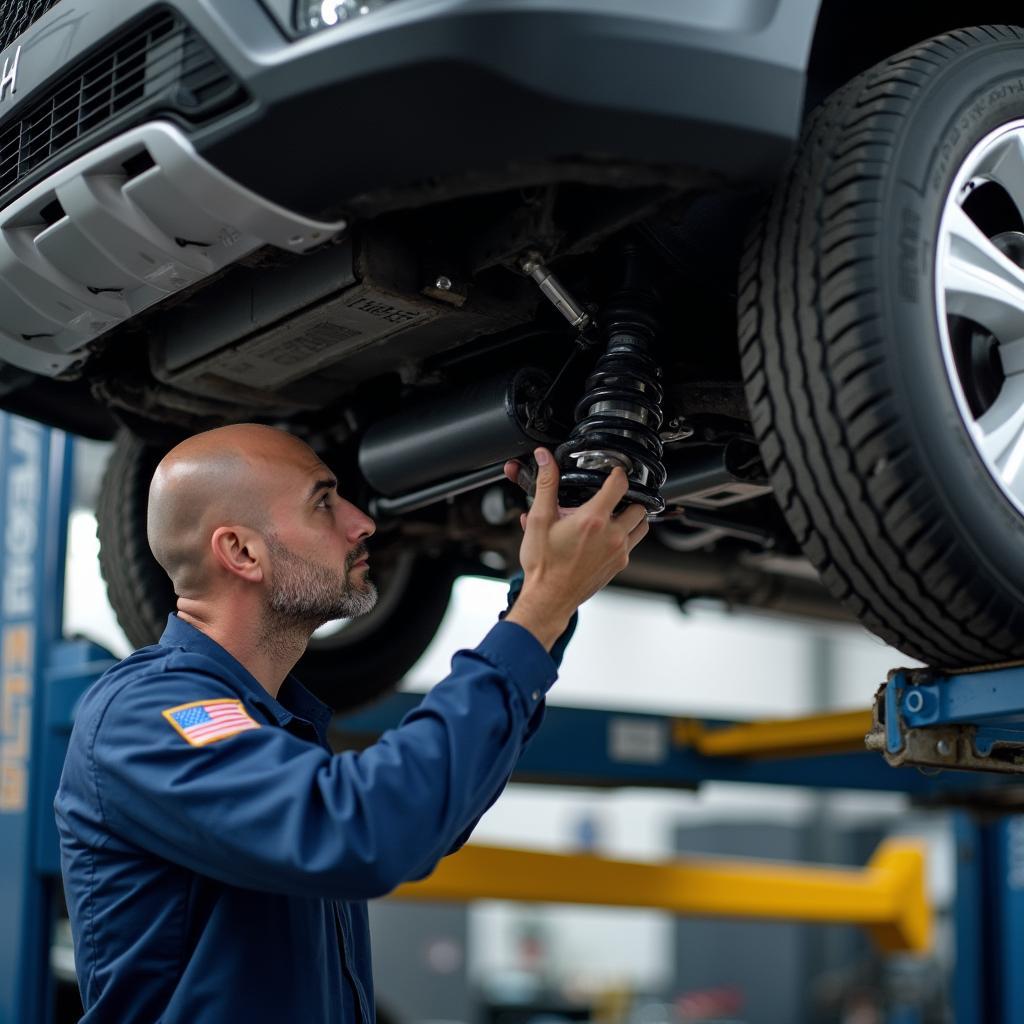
(506, 449, 649, 648)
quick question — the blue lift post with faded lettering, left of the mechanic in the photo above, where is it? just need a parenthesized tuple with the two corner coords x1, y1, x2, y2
(0, 414, 113, 1024)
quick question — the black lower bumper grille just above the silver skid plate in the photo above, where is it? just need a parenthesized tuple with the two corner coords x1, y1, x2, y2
(0, 11, 245, 199)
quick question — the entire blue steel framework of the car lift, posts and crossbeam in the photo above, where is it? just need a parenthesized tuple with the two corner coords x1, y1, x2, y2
(6, 405, 1024, 1024)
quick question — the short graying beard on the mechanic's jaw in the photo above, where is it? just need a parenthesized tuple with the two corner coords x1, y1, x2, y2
(266, 535, 377, 634)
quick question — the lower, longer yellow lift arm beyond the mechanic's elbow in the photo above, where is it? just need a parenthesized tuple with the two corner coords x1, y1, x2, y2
(393, 839, 933, 953)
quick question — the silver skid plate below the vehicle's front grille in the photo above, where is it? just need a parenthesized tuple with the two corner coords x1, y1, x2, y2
(0, 122, 345, 377)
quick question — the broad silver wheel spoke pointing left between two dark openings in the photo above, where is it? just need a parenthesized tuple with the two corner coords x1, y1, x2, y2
(941, 206, 1024, 340)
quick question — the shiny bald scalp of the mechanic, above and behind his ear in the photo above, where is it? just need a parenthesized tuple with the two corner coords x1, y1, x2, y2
(146, 423, 312, 598)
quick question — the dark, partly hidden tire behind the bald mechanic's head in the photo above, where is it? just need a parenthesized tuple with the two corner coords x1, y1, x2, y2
(96, 432, 455, 712)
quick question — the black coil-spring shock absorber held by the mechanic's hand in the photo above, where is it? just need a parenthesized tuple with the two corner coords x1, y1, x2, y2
(555, 246, 667, 516)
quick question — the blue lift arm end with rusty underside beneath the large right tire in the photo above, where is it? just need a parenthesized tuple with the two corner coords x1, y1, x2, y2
(867, 663, 1024, 774)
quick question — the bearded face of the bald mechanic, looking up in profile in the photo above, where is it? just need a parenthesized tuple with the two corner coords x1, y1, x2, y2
(265, 452, 377, 629)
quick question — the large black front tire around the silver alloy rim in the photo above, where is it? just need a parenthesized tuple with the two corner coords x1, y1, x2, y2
(739, 27, 1024, 668)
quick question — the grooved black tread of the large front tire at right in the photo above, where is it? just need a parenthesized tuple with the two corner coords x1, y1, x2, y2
(738, 26, 1024, 667)
